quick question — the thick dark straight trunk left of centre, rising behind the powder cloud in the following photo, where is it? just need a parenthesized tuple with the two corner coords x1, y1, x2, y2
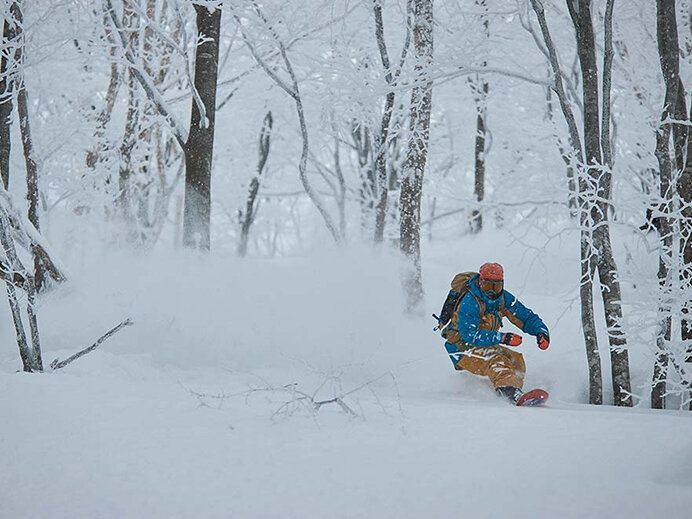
(183, 4, 221, 251)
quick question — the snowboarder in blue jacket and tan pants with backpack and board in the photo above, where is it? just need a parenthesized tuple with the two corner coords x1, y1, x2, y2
(438, 263, 550, 405)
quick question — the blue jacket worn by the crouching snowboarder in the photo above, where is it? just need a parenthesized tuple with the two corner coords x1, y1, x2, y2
(457, 275, 548, 347)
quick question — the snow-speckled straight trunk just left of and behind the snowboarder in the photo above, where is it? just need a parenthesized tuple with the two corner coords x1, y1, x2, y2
(399, 0, 433, 312)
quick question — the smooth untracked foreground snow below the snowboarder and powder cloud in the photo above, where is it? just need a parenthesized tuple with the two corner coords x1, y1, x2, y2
(5, 358, 692, 519)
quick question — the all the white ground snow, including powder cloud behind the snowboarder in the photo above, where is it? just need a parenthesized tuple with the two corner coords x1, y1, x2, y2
(0, 231, 692, 519)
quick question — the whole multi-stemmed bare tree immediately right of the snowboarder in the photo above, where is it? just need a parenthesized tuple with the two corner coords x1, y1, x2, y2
(531, 0, 632, 406)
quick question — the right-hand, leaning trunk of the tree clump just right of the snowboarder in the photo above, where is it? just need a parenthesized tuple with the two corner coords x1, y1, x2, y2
(567, 0, 632, 406)
